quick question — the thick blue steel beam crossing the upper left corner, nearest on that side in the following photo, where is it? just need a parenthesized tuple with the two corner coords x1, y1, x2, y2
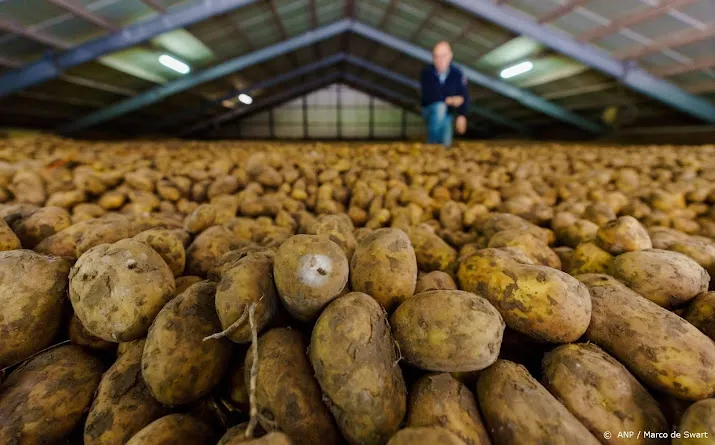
(0, 0, 258, 98)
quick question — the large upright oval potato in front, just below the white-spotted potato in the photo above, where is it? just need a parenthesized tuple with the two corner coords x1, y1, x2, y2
(309, 292, 406, 445)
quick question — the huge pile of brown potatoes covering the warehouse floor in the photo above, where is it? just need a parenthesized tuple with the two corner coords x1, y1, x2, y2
(0, 136, 715, 445)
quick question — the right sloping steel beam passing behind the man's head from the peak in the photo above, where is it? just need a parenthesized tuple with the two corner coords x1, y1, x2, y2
(352, 21, 603, 133)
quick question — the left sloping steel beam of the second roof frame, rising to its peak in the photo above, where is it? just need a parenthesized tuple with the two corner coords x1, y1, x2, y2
(59, 20, 351, 133)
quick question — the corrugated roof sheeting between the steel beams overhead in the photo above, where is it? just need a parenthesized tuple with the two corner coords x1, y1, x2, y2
(0, 0, 715, 137)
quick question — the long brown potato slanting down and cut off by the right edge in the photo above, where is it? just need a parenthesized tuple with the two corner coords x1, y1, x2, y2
(577, 274, 715, 400)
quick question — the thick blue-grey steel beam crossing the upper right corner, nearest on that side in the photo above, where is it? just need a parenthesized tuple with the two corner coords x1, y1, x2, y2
(445, 0, 715, 123)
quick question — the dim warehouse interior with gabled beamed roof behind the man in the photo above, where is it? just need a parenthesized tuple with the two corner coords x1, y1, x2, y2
(0, 0, 715, 140)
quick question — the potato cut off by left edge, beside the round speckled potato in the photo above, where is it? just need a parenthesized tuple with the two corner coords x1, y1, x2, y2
(0, 250, 70, 369)
